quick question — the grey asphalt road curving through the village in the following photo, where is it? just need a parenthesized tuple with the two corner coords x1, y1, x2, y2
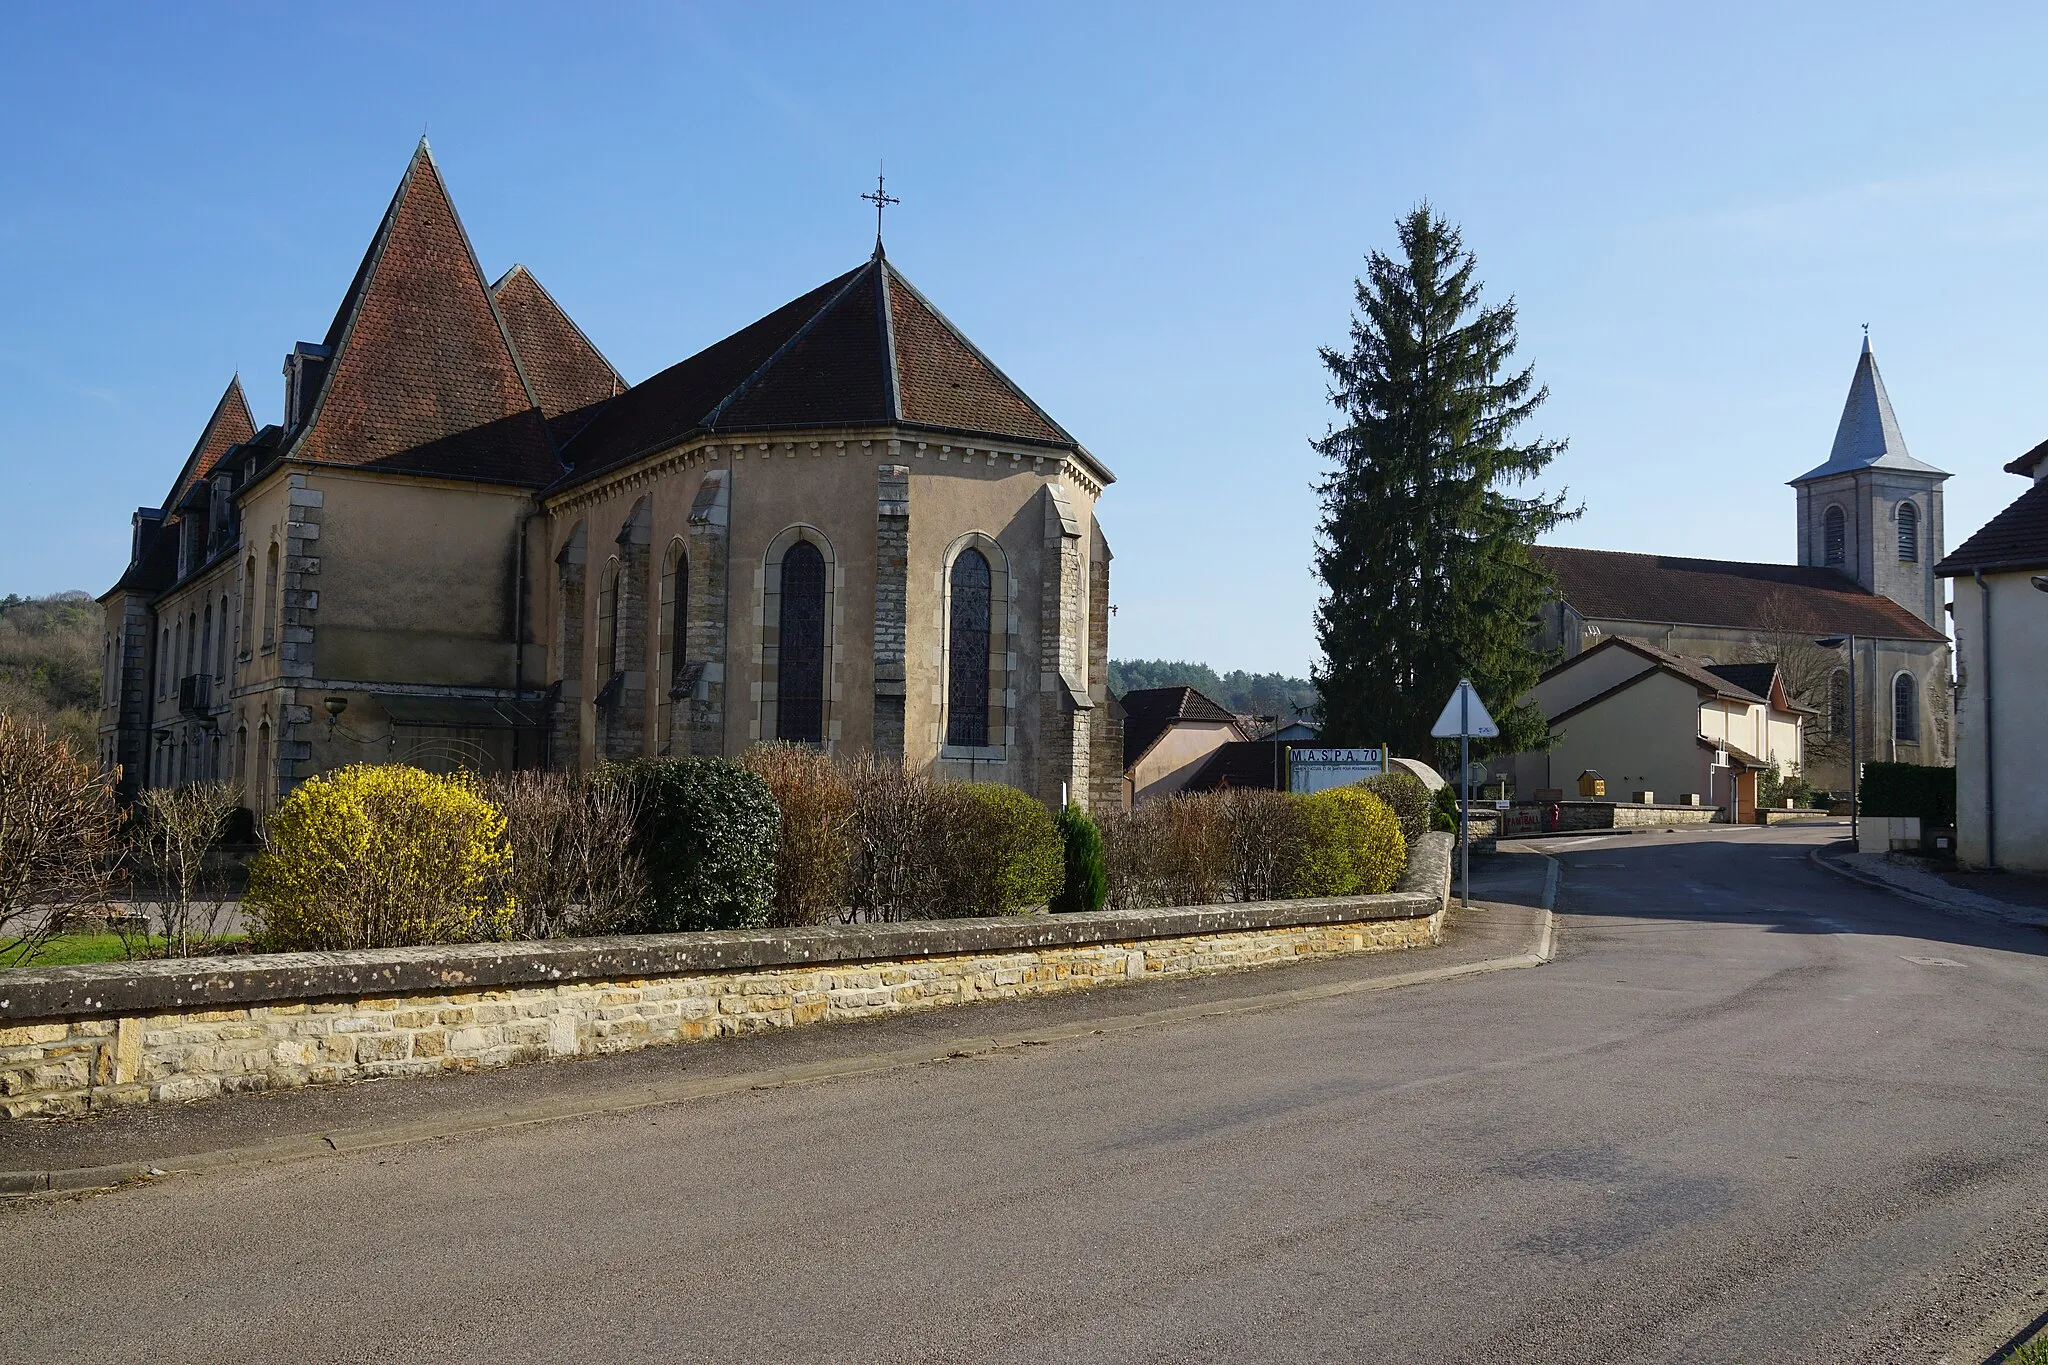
(0, 829, 2048, 1363)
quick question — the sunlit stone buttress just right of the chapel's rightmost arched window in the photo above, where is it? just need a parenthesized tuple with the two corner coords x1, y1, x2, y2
(1038, 483, 1096, 806)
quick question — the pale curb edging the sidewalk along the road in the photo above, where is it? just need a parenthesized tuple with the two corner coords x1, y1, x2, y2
(0, 912, 1559, 1199)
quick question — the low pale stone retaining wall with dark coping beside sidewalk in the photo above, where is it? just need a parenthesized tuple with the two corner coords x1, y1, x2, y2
(0, 835, 1450, 1117)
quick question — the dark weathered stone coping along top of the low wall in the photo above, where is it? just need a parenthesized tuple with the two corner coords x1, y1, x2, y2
(0, 833, 1450, 1021)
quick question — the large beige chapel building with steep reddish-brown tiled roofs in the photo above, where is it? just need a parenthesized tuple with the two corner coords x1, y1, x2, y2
(100, 139, 1122, 812)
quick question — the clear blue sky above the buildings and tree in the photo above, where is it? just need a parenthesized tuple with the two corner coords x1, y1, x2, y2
(0, 2, 2048, 671)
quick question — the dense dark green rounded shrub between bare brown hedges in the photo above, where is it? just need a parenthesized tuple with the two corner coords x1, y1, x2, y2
(604, 759, 782, 931)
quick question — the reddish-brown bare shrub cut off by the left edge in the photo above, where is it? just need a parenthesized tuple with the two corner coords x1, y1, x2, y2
(0, 712, 121, 962)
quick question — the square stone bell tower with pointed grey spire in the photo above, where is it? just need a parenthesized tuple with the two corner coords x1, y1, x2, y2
(1792, 334, 1948, 630)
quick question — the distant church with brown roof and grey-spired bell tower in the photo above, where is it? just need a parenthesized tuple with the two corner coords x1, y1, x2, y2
(1534, 338, 1956, 792)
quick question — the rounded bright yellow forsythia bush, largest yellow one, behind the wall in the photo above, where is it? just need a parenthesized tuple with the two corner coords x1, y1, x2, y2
(244, 763, 514, 952)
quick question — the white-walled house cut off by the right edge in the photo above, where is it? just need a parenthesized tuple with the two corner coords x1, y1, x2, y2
(1935, 442, 2048, 872)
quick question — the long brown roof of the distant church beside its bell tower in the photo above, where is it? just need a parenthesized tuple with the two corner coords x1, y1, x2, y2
(1532, 544, 1948, 641)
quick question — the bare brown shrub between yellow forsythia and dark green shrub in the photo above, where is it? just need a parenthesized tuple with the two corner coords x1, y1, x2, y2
(489, 772, 647, 939)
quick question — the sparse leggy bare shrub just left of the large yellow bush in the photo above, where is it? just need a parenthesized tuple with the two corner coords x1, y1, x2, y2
(128, 782, 242, 958)
